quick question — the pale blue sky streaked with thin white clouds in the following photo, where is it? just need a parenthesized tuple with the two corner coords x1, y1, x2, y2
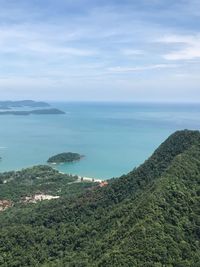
(0, 0, 200, 102)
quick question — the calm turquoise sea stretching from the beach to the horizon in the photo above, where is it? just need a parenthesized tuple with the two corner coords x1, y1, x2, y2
(0, 103, 200, 179)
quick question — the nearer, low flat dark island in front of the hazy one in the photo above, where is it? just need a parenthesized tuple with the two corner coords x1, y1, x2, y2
(0, 108, 65, 115)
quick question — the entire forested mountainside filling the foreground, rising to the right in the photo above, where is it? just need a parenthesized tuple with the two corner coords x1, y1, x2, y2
(0, 130, 200, 267)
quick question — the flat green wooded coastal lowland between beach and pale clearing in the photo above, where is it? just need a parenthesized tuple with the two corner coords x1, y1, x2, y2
(0, 165, 94, 202)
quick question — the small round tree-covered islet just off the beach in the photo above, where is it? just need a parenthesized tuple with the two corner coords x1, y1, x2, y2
(47, 152, 83, 163)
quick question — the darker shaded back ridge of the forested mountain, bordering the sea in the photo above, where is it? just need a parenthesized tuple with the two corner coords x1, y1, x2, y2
(104, 130, 200, 203)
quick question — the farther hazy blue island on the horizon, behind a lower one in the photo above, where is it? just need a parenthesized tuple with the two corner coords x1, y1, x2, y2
(0, 100, 50, 109)
